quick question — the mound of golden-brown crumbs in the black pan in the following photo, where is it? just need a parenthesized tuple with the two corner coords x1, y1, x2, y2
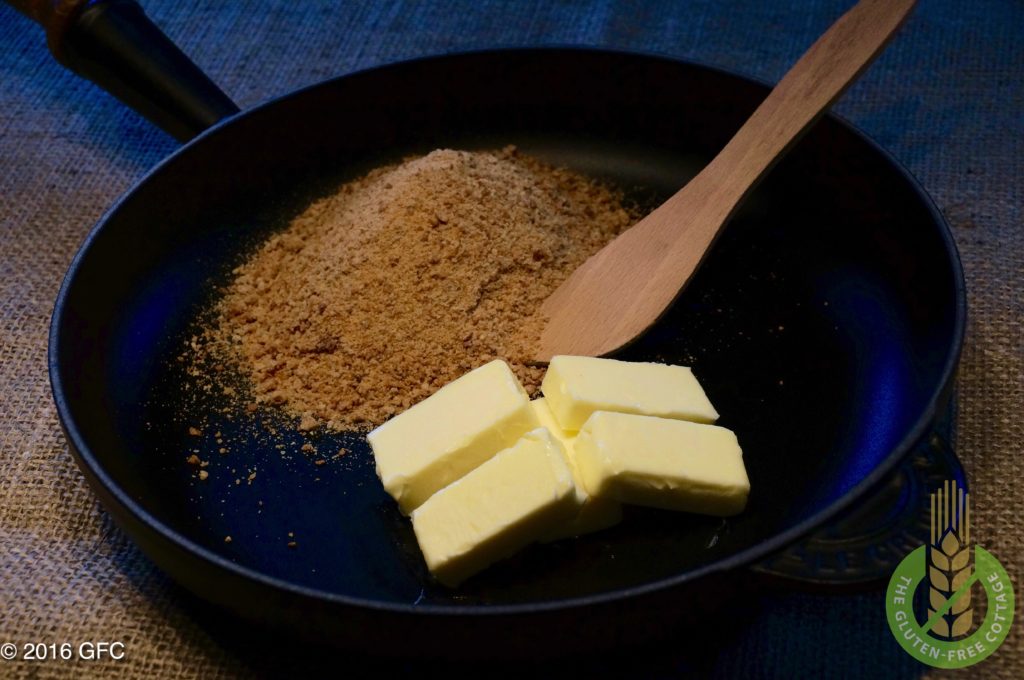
(189, 147, 638, 432)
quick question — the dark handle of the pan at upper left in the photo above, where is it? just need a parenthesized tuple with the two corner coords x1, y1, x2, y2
(5, 0, 239, 141)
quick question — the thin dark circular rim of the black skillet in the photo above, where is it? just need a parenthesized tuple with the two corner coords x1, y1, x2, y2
(47, 44, 967, 617)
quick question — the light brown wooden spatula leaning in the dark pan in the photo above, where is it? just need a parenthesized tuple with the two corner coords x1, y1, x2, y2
(537, 0, 915, 362)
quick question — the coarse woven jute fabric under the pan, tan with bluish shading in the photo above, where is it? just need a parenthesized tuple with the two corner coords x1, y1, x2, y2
(0, 0, 1024, 679)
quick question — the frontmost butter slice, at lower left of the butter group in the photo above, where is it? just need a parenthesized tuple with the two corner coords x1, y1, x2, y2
(412, 427, 580, 588)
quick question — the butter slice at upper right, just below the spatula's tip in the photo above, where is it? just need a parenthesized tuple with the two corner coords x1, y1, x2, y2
(541, 355, 718, 432)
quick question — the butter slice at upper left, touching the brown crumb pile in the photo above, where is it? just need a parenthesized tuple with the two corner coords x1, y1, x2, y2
(367, 360, 540, 515)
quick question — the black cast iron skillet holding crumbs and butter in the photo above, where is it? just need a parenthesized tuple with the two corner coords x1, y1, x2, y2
(14, 2, 965, 653)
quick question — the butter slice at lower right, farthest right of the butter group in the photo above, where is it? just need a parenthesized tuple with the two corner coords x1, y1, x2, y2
(575, 412, 751, 517)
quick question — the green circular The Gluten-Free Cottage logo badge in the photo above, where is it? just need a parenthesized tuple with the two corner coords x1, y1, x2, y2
(886, 546, 1014, 668)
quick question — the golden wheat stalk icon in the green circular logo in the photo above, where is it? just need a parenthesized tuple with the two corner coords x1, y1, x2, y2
(928, 480, 974, 640)
